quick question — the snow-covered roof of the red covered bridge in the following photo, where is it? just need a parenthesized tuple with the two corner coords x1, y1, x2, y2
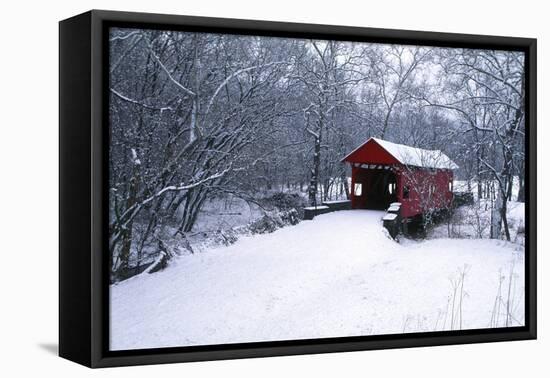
(342, 138, 458, 169)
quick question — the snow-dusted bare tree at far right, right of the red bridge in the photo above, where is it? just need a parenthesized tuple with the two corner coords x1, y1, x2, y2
(424, 49, 525, 240)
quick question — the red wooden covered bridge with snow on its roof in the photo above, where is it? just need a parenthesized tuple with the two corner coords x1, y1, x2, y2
(342, 138, 458, 218)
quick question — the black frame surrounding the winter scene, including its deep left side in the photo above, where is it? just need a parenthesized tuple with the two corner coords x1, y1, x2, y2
(59, 10, 537, 367)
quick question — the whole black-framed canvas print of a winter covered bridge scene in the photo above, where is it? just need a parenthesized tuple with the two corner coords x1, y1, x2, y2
(59, 11, 536, 367)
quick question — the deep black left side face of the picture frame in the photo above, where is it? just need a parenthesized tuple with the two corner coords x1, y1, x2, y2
(59, 12, 94, 366)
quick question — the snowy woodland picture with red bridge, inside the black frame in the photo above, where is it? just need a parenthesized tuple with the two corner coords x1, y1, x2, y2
(105, 27, 528, 351)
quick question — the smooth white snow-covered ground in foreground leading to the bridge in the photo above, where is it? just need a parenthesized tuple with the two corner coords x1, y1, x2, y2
(111, 210, 524, 350)
